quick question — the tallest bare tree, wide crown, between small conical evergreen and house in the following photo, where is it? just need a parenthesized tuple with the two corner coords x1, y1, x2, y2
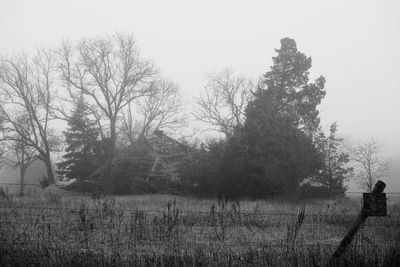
(60, 35, 155, 176)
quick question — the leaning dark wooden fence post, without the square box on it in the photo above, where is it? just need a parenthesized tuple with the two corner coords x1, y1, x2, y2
(330, 180, 386, 264)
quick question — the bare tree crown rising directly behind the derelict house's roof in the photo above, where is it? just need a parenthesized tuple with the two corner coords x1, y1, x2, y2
(121, 79, 184, 144)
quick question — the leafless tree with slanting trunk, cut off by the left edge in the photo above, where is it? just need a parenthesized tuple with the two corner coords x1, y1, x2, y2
(0, 49, 56, 184)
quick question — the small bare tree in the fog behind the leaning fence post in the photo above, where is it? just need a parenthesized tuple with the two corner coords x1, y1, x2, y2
(350, 139, 390, 192)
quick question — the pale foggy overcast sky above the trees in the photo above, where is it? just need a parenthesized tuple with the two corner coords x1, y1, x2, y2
(0, 0, 400, 157)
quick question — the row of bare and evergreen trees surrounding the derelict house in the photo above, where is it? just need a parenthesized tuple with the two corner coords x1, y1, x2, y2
(0, 35, 385, 198)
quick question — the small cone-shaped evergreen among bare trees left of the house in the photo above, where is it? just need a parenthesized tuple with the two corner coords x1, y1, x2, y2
(57, 96, 101, 179)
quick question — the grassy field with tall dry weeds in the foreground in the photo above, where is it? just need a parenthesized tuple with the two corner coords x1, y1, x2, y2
(0, 187, 400, 266)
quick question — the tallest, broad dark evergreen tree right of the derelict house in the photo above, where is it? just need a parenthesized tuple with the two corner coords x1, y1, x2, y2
(228, 38, 325, 196)
